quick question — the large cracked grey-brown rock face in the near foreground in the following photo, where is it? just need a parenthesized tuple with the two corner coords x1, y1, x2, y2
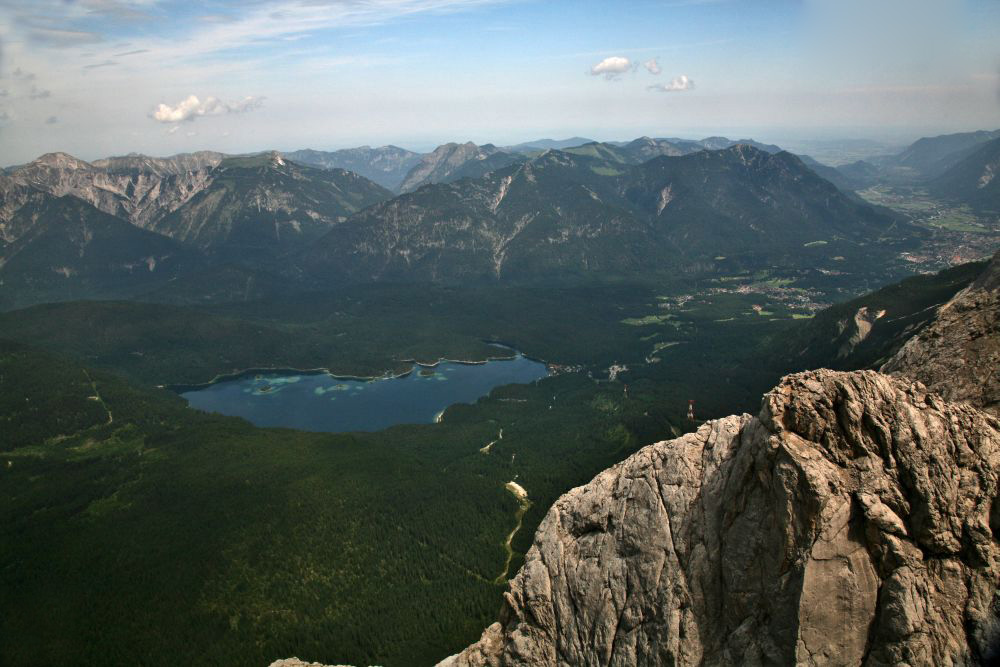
(442, 370, 1000, 667)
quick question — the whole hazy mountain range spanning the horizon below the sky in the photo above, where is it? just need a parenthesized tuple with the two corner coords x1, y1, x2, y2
(7, 132, 1000, 307)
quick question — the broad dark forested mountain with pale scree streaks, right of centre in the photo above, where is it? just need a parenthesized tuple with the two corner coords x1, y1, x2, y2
(291, 145, 899, 282)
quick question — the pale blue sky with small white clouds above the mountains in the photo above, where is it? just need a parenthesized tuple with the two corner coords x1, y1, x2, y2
(0, 0, 1000, 165)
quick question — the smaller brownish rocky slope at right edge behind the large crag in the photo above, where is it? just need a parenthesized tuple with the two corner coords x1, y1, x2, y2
(882, 252, 1000, 416)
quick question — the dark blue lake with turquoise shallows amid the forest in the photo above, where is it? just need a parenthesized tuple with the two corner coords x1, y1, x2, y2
(181, 355, 548, 432)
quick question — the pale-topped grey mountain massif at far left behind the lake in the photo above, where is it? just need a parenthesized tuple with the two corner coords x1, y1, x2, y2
(0, 152, 392, 309)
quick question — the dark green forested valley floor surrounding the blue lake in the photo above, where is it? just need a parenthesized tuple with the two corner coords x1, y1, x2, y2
(0, 232, 996, 665)
